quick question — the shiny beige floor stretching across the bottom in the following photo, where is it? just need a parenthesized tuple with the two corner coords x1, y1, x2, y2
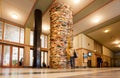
(0, 68, 120, 78)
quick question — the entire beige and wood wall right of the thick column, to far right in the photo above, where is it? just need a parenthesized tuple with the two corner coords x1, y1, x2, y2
(73, 34, 114, 67)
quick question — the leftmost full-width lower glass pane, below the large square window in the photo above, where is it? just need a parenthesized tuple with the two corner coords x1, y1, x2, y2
(3, 46, 10, 66)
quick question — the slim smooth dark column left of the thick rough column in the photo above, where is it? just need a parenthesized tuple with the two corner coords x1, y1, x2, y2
(33, 9, 42, 68)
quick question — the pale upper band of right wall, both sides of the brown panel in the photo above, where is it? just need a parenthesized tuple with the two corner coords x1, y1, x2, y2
(73, 34, 114, 57)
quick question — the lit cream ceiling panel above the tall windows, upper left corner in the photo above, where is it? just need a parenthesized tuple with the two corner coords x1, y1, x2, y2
(0, 0, 35, 25)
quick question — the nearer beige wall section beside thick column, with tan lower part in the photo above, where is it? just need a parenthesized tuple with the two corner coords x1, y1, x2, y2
(73, 34, 96, 67)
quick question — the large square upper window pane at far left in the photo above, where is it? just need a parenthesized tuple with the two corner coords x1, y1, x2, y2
(4, 24, 20, 42)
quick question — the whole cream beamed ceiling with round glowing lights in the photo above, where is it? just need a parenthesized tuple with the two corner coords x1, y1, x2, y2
(0, 0, 120, 52)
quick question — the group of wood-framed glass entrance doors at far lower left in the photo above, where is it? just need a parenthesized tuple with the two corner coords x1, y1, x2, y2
(1, 45, 24, 67)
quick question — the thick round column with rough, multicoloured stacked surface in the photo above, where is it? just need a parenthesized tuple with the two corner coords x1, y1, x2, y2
(50, 3, 73, 68)
